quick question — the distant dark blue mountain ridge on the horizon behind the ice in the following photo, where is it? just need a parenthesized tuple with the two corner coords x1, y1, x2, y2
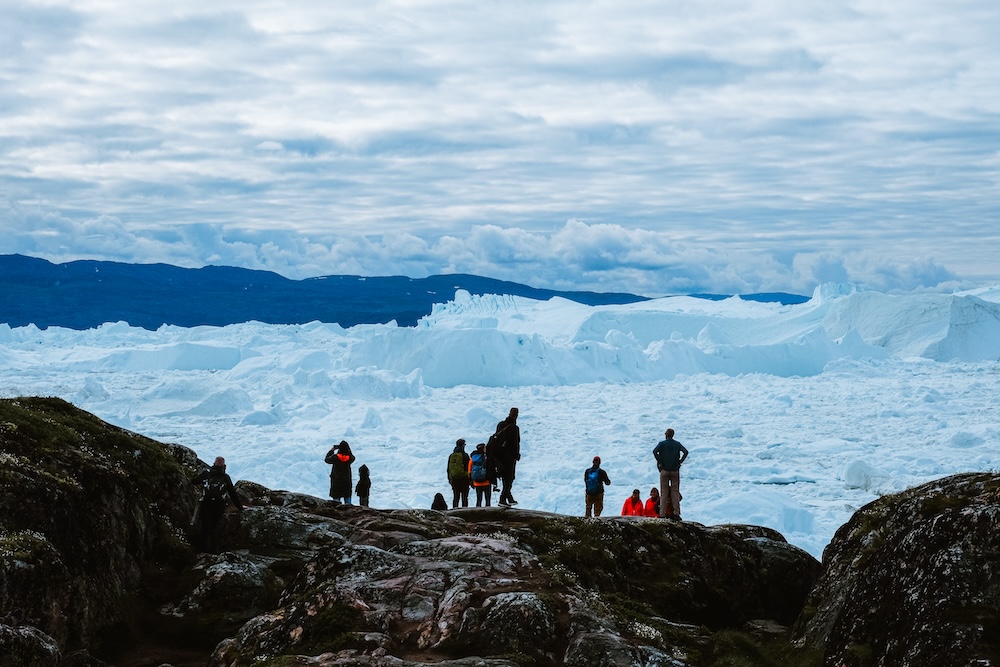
(0, 255, 806, 330)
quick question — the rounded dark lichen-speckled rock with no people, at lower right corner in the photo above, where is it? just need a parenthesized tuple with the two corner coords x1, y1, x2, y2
(796, 474, 1000, 667)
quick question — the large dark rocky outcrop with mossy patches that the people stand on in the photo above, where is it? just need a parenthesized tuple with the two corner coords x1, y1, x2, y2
(0, 399, 820, 667)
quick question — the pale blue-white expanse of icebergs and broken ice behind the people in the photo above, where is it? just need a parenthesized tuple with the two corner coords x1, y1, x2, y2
(0, 285, 1000, 557)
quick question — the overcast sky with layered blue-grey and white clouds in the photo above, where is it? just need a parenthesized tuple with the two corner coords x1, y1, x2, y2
(0, 0, 1000, 295)
